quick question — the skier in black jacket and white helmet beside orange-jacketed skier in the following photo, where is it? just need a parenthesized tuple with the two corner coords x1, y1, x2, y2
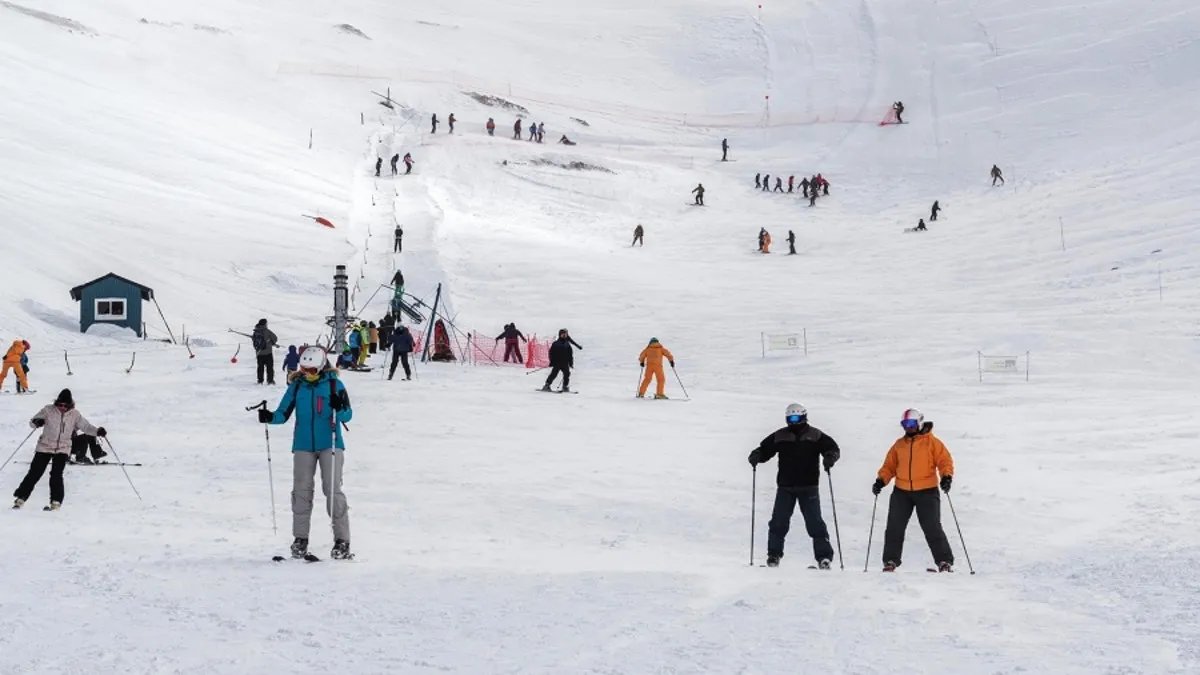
(748, 404, 841, 569)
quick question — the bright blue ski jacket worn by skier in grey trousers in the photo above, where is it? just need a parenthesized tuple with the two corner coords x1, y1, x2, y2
(271, 370, 354, 453)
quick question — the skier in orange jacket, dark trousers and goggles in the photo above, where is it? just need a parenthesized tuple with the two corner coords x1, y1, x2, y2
(871, 408, 954, 572)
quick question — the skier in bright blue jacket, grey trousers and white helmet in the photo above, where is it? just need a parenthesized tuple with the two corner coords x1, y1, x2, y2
(258, 346, 354, 560)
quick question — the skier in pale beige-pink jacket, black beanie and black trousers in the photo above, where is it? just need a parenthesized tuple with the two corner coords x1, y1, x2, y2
(12, 389, 108, 510)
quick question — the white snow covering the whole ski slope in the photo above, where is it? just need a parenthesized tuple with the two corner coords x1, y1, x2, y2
(0, 0, 1200, 674)
